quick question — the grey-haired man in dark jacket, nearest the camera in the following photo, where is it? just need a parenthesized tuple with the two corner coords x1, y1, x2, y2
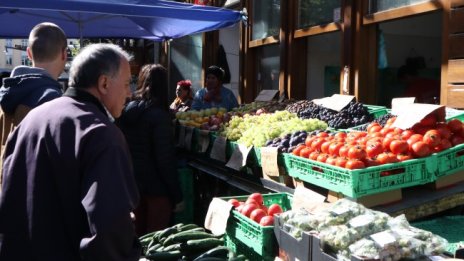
(0, 44, 141, 261)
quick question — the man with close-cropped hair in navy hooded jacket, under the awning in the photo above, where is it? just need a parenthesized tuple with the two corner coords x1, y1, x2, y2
(0, 23, 67, 188)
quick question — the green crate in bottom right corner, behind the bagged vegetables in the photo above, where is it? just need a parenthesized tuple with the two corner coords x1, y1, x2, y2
(411, 216, 464, 255)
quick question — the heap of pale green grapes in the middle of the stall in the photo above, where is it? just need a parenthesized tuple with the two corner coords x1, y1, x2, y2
(221, 111, 327, 147)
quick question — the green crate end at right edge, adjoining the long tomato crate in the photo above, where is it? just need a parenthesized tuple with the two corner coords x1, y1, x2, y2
(432, 144, 464, 178)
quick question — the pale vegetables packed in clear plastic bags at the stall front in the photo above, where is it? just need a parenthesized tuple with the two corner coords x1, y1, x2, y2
(278, 199, 447, 260)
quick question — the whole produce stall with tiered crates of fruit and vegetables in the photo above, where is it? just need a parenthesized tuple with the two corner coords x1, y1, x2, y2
(169, 94, 464, 260)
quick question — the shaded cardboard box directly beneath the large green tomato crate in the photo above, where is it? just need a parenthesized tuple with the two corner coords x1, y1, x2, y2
(327, 189, 402, 208)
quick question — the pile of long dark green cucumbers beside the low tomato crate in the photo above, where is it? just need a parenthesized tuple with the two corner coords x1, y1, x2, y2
(139, 223, 241, 261)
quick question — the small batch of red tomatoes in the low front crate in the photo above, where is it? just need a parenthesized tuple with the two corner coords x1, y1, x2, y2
(228, 193, 283, 226)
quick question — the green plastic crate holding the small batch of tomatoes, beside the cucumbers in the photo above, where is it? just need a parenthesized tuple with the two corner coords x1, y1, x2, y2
(221, 193, 292, 260)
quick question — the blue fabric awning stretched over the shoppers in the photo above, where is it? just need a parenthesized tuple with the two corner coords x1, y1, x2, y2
(0, 0, 242, 41)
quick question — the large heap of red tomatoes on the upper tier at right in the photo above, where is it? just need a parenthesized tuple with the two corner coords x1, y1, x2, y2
(292, 114, 464, 169)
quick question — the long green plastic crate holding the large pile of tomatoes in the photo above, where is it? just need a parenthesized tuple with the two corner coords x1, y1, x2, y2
(284, 153, 437, 198)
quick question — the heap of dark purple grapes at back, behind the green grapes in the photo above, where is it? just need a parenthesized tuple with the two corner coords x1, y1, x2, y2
(298, 101, 373, 129)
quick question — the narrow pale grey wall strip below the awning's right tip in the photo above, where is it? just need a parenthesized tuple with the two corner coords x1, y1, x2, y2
(219, 24, 240, 102)
